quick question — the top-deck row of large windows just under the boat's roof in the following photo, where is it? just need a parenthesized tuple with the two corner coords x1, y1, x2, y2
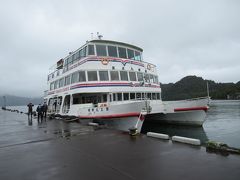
(64, 44, 142, 66)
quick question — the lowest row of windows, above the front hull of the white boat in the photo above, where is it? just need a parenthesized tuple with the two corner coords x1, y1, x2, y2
(72, 92, 161, 104)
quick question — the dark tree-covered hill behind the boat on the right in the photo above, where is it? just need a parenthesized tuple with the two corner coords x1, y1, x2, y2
(161, 76, 240, 100)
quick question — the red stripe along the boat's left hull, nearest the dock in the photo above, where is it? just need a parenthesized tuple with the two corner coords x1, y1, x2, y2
(79, 112, 140, 119)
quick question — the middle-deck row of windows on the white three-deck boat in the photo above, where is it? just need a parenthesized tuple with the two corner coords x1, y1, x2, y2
(50, 70, 159, 90)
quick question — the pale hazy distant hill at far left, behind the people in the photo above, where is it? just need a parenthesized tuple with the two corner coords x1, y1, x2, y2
(0, 95, 43, 106)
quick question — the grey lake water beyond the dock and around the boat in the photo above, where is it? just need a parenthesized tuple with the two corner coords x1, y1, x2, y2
(2, 100, 240, 148)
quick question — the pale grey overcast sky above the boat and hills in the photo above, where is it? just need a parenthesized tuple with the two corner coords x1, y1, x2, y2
(0, 0, 240, 97)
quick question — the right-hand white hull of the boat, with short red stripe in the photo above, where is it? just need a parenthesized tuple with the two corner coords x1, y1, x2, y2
(146, 97, 210, 126)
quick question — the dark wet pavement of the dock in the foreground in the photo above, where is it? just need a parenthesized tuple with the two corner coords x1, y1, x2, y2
(0, 110, 240, 180)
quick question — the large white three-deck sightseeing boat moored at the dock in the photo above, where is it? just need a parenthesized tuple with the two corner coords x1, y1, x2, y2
(44, 38, 208, 132)
